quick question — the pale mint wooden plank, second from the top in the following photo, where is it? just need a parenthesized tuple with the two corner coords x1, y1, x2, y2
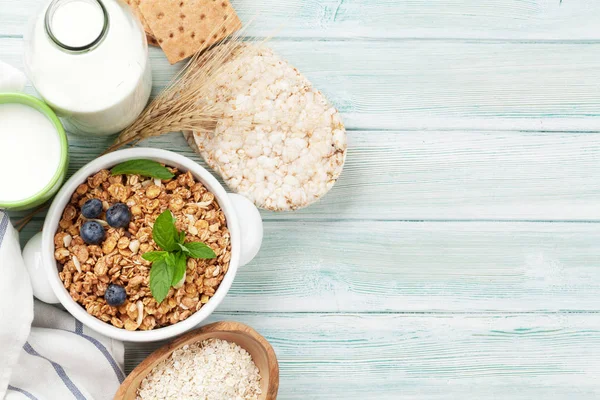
(0, 38, 600, 131)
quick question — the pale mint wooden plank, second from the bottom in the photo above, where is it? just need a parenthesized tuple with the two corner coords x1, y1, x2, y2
(16, 221, 600, 312)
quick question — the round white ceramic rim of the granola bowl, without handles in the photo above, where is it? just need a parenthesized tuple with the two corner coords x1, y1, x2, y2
(42, 148, 241, 342)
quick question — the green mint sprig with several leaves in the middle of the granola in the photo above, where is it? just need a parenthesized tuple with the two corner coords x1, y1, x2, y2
(142, 210, 217, 303)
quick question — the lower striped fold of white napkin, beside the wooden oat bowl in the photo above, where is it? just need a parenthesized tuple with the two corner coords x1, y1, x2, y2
(4, 301, 125, 400)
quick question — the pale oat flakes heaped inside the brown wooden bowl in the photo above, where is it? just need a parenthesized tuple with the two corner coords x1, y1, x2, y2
(137, 339, 261, 400)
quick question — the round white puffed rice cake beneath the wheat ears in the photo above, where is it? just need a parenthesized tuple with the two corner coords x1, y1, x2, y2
(184, 45, 347, 211)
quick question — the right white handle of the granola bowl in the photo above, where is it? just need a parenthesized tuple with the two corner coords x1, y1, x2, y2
(228, 193, 263, 266)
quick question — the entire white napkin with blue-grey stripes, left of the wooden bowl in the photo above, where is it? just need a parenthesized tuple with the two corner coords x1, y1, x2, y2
(0, 211, 125, 400)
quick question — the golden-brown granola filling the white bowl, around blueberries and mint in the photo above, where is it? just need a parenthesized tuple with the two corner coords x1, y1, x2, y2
(54, 168, 231, 331)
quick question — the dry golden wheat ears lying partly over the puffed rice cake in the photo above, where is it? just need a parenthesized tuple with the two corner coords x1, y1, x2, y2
(103, 16, 249, 154)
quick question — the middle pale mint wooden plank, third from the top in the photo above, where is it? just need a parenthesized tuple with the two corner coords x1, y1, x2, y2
(9, 131, 600, 225)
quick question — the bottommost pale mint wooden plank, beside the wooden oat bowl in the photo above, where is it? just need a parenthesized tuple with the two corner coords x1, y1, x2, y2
(126, 313, 600, 400)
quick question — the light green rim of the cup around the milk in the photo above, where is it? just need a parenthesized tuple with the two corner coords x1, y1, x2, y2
(0, 93, 69, 211)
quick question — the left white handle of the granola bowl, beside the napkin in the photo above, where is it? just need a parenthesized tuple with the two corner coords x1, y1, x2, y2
(23, 232, 60, 304)
